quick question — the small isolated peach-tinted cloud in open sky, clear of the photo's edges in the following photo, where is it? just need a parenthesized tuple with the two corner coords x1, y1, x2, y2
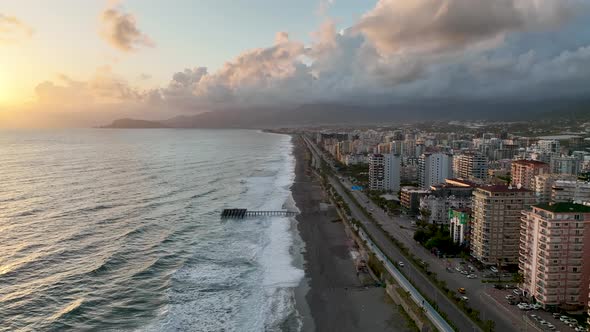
(100, 7, 155, 52)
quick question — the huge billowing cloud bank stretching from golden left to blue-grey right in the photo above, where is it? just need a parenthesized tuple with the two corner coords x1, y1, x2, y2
(23, 0, 590, 118)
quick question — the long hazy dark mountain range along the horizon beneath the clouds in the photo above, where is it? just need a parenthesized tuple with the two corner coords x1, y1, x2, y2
(102, 99, 590, 128)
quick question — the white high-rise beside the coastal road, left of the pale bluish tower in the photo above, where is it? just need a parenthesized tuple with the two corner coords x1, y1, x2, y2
(369, 154, 401, 192)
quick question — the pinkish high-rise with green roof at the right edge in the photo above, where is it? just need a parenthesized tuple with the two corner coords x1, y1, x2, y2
(519, 203, 590, 309)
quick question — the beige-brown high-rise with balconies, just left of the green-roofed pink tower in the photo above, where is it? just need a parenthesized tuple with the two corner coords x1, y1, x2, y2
(471, 185, 535, 265)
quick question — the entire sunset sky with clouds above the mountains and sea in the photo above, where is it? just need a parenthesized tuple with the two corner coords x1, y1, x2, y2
(0, 0, 590, 127)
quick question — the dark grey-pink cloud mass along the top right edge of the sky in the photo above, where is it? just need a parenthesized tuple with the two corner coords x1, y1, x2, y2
(355, 0, 582, 54)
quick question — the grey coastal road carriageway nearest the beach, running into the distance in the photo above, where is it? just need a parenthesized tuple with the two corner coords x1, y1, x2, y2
(305, 138, 481, 331)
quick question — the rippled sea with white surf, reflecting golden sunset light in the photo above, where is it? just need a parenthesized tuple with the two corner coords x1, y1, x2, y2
(0, 129, 304, 331)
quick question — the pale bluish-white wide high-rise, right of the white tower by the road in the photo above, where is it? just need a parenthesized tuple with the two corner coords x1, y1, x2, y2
(418, 153, 453, 189)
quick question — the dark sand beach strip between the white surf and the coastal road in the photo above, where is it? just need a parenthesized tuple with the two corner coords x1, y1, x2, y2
(292, 136, 409, 332)
